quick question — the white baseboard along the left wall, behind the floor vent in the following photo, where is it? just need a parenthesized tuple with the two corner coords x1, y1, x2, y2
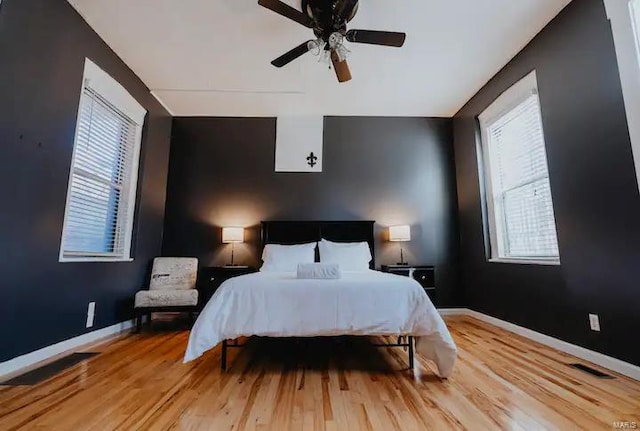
(0, 320, 134, 381)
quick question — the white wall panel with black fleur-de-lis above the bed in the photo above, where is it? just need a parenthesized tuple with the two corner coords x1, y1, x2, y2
(276, 116, 324, 172)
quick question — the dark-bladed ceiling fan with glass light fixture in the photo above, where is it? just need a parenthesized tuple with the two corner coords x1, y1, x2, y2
(258, 0, 407, 82)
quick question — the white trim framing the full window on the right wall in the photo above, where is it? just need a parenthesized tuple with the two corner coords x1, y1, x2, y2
(478, 70, 560, 265)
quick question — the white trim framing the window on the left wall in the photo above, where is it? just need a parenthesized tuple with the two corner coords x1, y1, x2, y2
(58, 58, 147, 263)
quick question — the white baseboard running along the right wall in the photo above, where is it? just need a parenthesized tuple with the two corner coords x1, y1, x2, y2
(438, 308, 640, 381)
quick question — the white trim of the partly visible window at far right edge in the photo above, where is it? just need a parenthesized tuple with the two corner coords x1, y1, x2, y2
(604, 0, 640, 194)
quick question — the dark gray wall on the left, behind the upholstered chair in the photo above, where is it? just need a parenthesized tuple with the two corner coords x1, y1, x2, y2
(0, 0, 171, 362)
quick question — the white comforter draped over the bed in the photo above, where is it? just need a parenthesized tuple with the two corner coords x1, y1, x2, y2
(184, 271, 457, 377)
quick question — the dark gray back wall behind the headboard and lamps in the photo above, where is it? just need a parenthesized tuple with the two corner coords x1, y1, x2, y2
(163, 117, 459, 305)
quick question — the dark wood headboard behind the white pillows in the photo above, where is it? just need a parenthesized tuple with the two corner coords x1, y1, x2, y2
(261, 221, 376, 269)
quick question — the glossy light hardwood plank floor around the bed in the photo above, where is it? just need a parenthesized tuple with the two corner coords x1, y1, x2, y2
(0, 317, 640, 431)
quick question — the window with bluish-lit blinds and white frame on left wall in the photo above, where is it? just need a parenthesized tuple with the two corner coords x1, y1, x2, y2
(60, 59, 146, 261)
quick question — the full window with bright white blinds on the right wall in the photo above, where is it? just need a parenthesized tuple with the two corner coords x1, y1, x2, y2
(480, 72, 559, 263)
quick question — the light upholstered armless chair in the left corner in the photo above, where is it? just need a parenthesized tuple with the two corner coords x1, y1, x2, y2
(135, 257, 198, 331)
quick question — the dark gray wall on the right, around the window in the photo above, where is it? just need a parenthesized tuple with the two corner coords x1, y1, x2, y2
(454, 0, 640, 365)
